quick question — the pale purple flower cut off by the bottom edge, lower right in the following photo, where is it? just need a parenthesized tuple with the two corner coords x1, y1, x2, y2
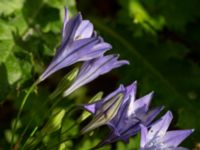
(140, 111, 194, 150)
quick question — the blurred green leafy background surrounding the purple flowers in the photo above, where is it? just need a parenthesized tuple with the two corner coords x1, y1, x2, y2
(0, 0, 200, 150)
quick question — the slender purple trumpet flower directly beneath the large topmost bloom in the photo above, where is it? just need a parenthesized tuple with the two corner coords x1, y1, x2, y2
(64, 55, 129, 96)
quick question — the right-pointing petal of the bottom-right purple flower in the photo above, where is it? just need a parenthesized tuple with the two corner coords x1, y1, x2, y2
(162, 129, 194, 147)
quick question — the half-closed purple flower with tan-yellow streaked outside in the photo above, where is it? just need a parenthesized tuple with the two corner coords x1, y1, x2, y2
(81, 85, 126, 133)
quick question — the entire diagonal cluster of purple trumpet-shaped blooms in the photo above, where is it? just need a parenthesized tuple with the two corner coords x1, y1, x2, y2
(39, 8, 193, 150)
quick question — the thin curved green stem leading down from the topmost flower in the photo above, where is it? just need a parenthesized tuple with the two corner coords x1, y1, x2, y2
(11, 80, 38, 149)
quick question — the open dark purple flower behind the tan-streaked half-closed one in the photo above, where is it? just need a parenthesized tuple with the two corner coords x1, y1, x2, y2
(84, 82, 162, 147)
